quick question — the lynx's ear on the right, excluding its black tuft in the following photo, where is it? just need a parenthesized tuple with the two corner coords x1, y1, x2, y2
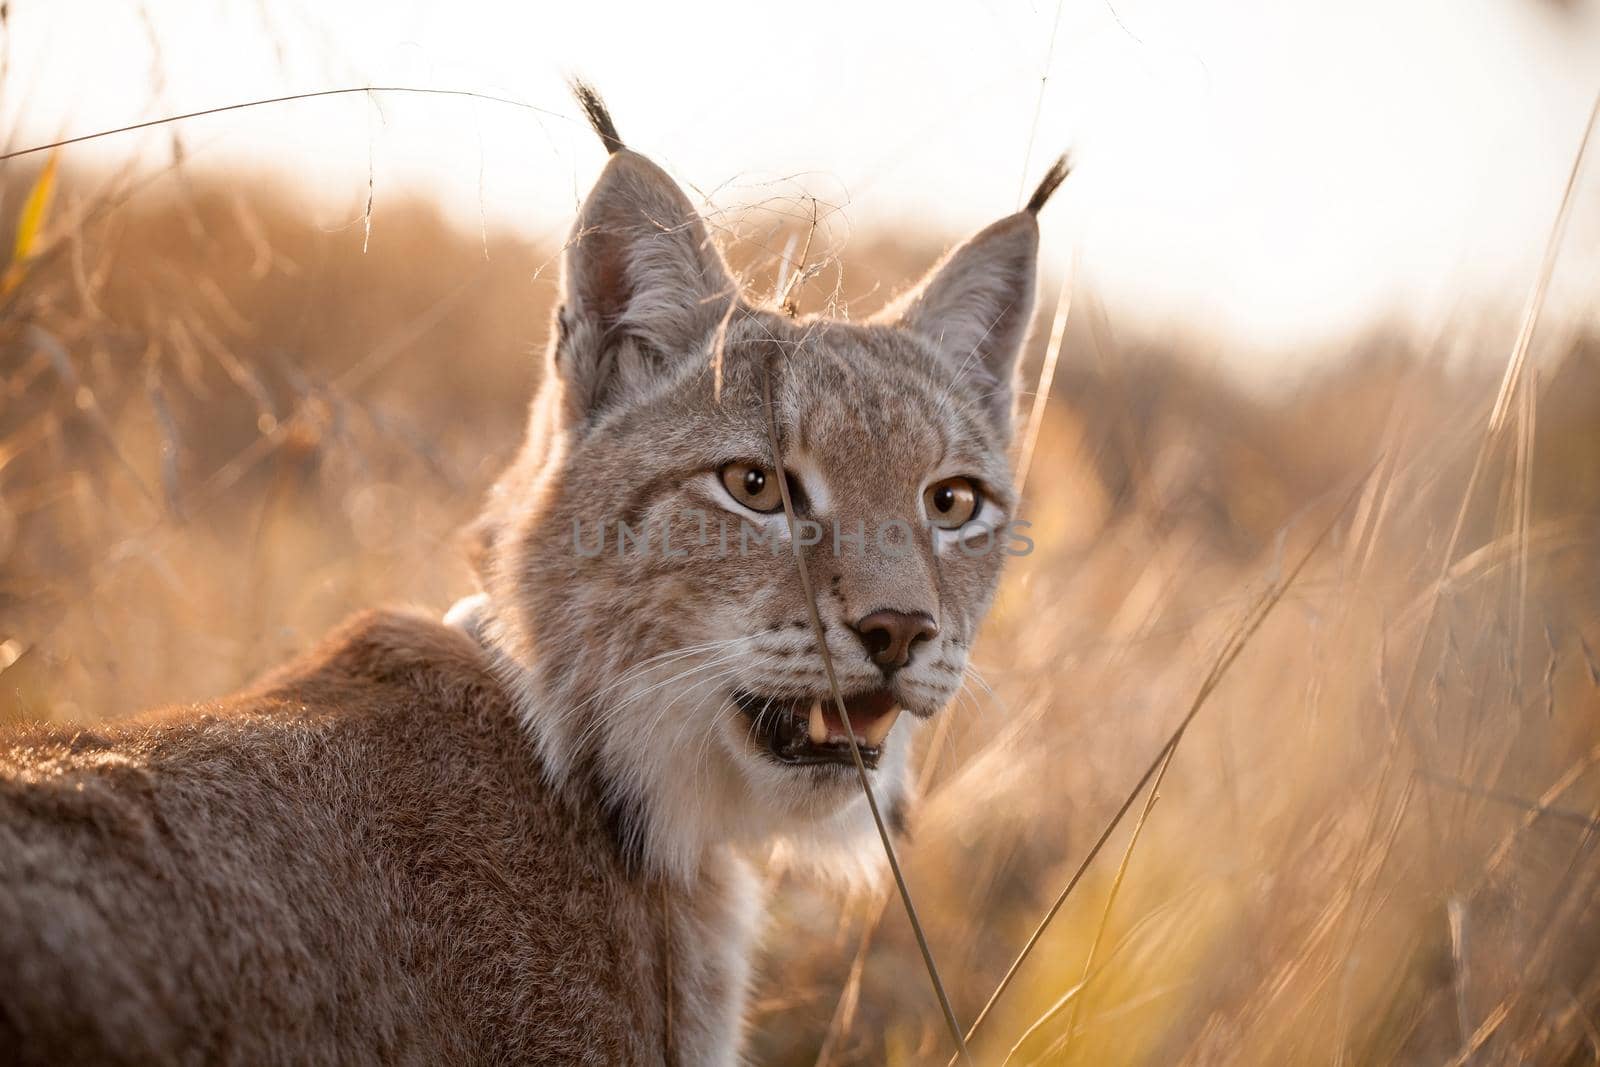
(886, 211, 1038, 429)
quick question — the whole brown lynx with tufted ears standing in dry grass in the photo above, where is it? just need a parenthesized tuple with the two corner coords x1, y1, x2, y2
(0, 85, 1066, 1064)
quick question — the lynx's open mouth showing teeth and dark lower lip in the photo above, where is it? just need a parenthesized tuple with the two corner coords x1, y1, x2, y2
(733, 689, 901, 768)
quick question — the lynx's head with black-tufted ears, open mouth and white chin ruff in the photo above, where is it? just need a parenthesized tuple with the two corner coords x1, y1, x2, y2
(467, 88, 1066, 875)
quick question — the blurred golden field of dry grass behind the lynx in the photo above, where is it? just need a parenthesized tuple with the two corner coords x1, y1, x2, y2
(0, 2, 1600, 1065)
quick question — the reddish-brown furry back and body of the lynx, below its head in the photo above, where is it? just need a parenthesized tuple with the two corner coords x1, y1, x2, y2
(0, 614, 748, 1064)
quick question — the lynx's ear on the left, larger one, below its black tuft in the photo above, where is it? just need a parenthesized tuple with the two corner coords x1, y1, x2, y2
(555, 147, 736, 413)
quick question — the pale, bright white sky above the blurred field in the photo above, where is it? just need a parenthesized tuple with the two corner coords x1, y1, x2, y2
(0, 0, 1600, 360)
